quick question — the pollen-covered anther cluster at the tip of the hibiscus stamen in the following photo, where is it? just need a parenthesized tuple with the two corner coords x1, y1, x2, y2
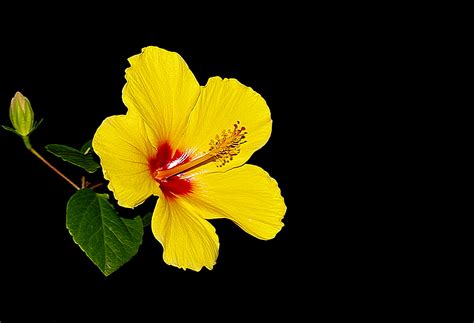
(209, 121, 247, 167)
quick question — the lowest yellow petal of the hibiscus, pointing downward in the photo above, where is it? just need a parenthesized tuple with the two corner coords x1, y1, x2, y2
(151, 198, 219, 271)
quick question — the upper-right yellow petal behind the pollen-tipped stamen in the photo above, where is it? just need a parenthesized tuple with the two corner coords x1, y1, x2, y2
(180, 77, 272, 172)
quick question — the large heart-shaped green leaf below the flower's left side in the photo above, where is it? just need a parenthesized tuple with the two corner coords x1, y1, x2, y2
(66, 189, 143, 276)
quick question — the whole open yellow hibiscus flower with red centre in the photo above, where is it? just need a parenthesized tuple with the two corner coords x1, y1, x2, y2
(92, 47, 286, 271)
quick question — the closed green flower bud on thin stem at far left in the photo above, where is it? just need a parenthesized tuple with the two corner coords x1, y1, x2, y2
(10, 92, 35, 137)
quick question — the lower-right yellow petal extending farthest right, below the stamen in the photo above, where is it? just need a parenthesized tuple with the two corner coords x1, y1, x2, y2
(181, 165, 286, 240)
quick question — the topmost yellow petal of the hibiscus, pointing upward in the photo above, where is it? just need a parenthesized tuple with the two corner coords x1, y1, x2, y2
(122, 47, 200, 147)
